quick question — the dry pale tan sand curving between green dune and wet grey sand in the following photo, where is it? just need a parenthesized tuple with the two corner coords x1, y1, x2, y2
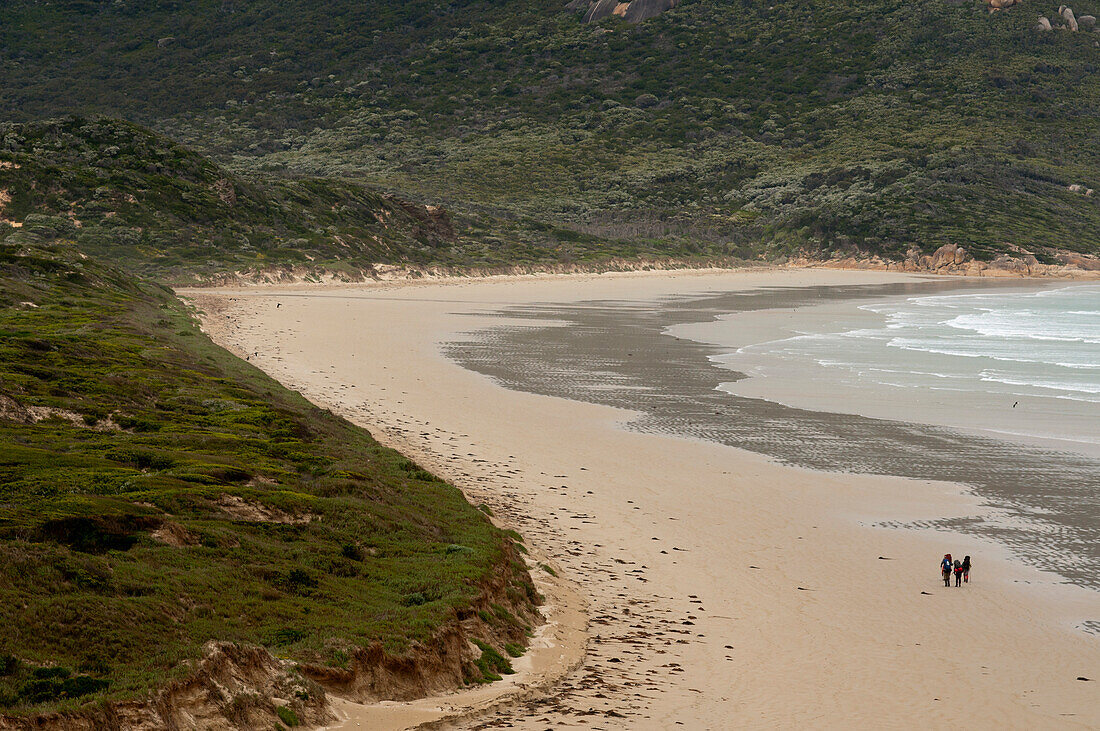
(182, 269, 1100, 729)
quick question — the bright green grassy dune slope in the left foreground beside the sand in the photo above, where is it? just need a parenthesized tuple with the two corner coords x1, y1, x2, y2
(0, 239, 534, 713)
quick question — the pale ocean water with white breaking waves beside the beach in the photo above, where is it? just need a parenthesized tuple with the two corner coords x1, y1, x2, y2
(714, 285, 1100, 454)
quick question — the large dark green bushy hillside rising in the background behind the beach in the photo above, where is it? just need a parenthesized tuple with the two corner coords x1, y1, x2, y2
(0, 0, 1100, 256)
